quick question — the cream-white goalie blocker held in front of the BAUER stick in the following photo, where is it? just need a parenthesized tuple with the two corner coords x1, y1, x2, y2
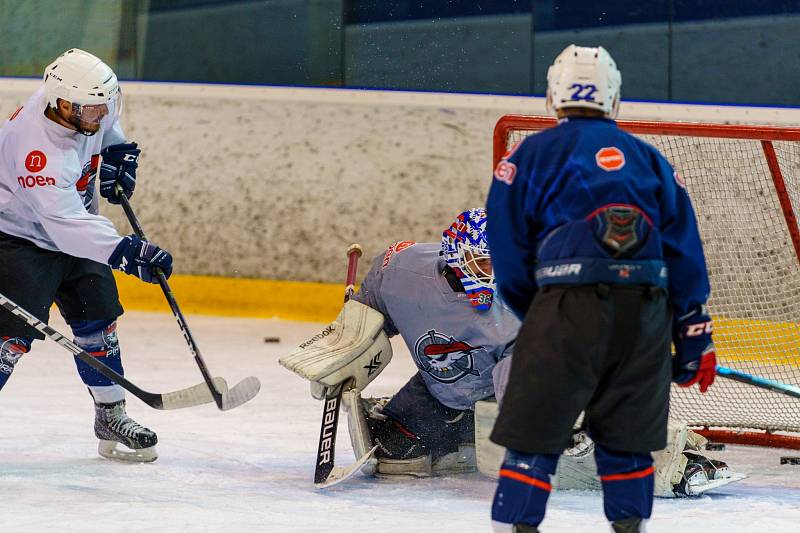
(279, 300, 392, 392)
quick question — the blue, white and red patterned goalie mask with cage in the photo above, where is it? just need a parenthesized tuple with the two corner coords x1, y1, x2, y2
(441, 208, 495, 311)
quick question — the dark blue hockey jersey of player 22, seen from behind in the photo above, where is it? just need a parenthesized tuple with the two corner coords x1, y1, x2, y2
(486, 117, 709, 318)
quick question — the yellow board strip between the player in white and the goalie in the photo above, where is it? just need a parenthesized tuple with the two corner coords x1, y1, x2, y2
(114, 272, 344, 322)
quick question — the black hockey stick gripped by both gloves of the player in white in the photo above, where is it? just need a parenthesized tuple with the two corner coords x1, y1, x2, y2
(117, 191, 261, 411)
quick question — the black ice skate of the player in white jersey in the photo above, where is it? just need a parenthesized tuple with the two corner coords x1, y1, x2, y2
(94, 400, 158, 463)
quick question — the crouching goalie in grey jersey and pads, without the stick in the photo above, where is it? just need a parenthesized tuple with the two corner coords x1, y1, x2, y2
(280, 209, 743, 497)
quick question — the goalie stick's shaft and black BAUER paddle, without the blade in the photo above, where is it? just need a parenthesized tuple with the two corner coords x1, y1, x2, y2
(314, 244, 362, 487)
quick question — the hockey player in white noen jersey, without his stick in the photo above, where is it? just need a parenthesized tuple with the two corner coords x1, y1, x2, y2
(0, 49, 172, 461)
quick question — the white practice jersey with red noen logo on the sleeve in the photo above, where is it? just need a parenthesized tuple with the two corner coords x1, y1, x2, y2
(0, 88, 125, 263)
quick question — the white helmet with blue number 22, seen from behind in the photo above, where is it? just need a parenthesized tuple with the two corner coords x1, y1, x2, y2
(547, 44, 622, 118)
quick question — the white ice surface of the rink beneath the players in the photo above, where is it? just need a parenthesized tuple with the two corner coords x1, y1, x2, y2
(0, 312, 800, 533)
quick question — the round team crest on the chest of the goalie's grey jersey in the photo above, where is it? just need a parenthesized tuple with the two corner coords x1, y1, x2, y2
(412, 329, 483, 383)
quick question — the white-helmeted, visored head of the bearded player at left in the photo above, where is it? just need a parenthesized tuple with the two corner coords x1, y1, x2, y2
(44, 48, 122, 135)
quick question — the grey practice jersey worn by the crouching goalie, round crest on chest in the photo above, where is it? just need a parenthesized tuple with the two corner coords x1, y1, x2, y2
(354, 241, 520, 410)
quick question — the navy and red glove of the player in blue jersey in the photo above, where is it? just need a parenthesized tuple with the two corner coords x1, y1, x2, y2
(672, 307, 717, 392)
